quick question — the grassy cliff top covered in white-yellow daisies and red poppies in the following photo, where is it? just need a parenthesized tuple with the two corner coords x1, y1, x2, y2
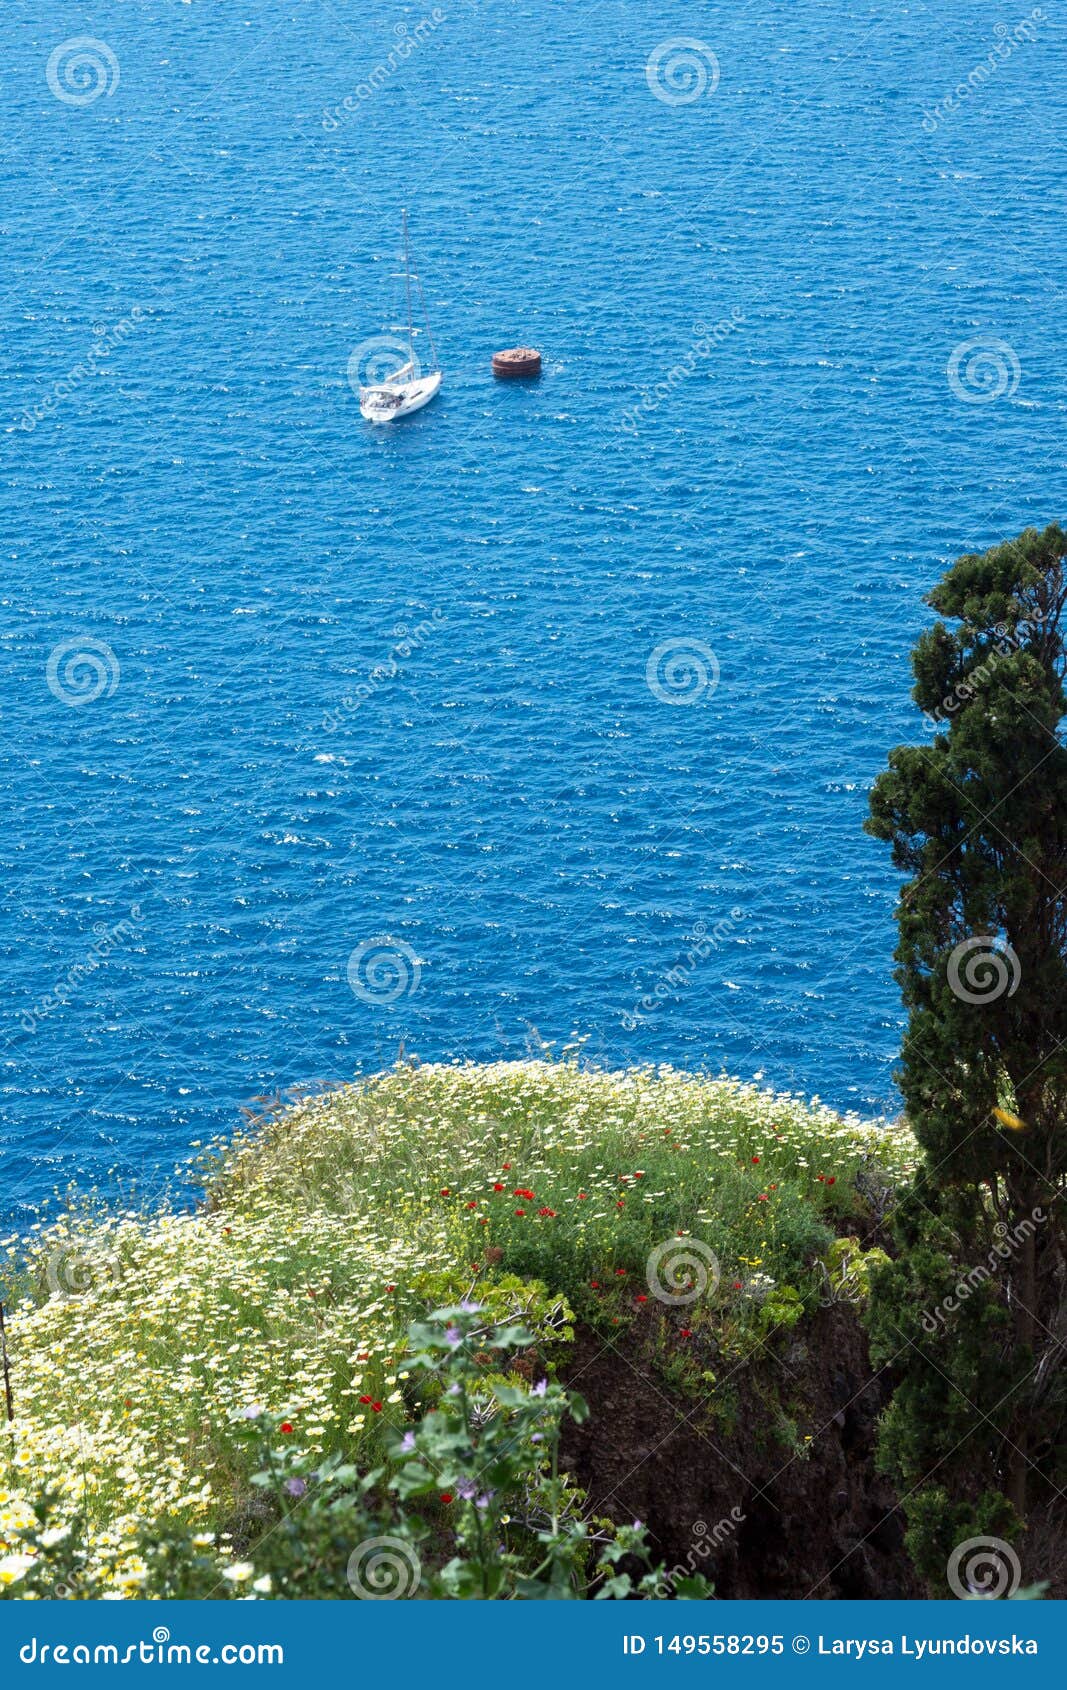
(0, 1061, 915, 1595)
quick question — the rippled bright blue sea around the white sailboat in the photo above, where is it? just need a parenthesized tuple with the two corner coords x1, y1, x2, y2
(0, 0, 1067, 1224)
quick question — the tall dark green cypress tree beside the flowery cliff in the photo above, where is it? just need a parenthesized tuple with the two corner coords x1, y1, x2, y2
(866, 526, 1067, 1590)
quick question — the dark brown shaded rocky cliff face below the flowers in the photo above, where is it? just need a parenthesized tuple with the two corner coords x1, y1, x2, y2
(561, 1305, 923, 1599)
